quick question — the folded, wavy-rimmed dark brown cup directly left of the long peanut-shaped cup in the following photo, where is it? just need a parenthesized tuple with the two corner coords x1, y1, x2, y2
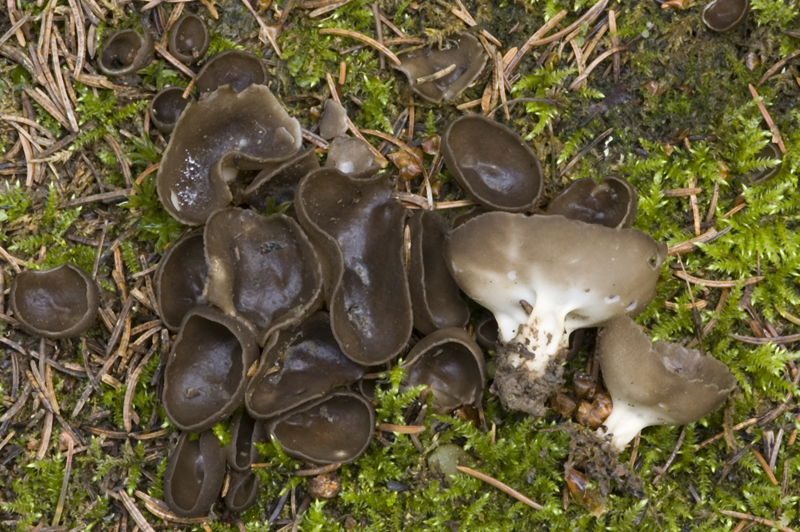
(204, 208, 322, 345)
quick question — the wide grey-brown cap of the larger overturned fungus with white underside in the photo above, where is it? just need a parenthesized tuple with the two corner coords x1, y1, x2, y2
(445, 212, 667, 342)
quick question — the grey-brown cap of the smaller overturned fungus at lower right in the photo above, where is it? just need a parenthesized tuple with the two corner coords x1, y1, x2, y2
(597, 316, 736, 425)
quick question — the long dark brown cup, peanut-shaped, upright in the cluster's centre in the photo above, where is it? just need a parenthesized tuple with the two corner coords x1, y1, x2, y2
(295, 168, 413, 366)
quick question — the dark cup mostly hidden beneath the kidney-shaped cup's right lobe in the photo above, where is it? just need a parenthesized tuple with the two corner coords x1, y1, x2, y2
(244, 146, 319, 212)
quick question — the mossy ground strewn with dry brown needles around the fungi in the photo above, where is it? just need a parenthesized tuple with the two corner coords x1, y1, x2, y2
(0, 0, 800, 531)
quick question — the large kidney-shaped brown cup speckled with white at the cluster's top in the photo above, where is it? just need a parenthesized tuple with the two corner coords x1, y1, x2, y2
(157, 85, 303, 225)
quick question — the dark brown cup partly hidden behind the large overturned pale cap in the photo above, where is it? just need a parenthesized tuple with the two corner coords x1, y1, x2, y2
(547, 176, 638, 229)
